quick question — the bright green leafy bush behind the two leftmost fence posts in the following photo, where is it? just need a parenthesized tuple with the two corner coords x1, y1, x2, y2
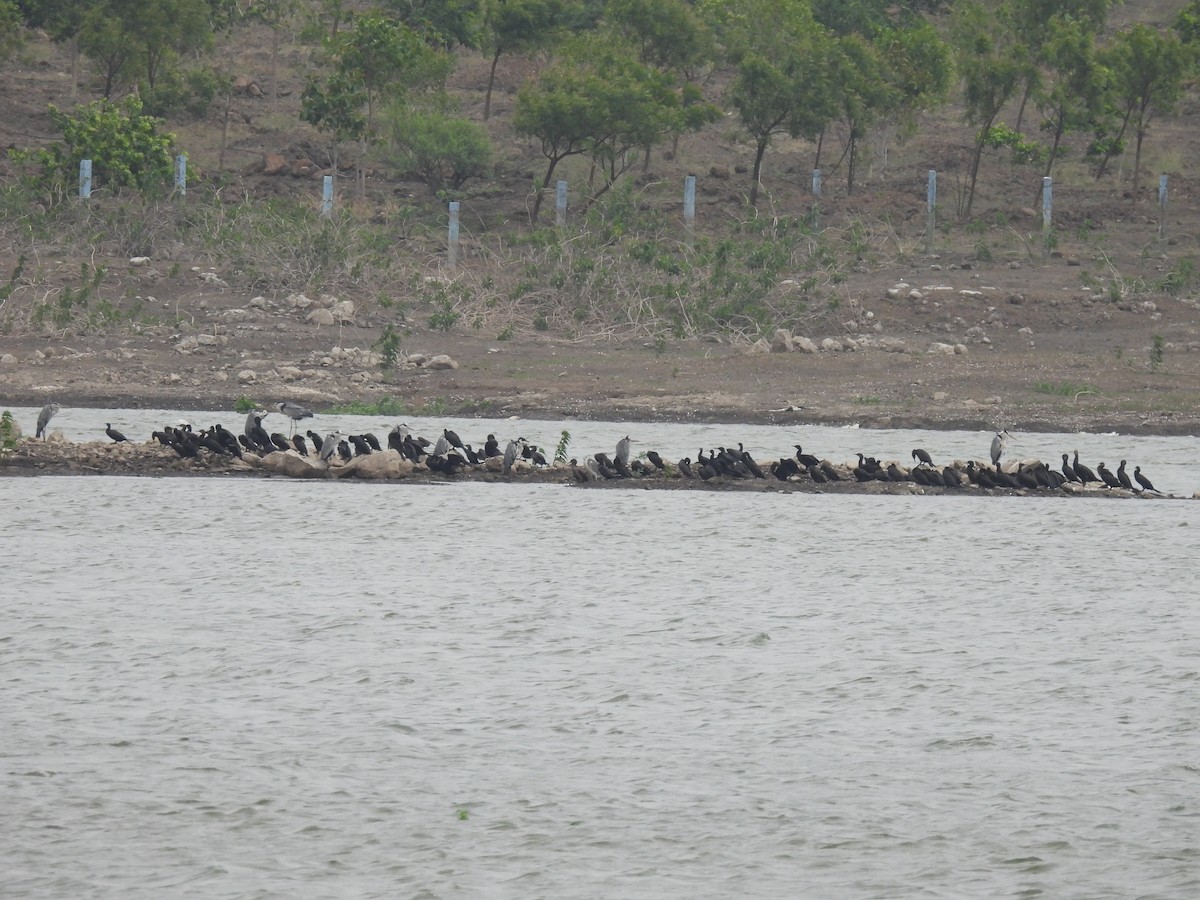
(11, 96, 175, 190)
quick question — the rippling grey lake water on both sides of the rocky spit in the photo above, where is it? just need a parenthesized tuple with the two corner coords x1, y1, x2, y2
(0, 410, 1200, 898)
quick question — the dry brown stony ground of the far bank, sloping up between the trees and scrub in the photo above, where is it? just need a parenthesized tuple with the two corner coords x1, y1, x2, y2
(0, 13, 1200, 433)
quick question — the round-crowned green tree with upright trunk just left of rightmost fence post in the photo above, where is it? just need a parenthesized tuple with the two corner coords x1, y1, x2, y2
(1100, 23, 1188, 198)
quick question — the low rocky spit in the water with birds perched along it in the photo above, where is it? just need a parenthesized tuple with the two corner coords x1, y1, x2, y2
(0, 436, 1170, 499)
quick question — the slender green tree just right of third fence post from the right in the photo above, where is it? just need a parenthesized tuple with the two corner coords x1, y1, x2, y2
(952, 0, 1024, 217)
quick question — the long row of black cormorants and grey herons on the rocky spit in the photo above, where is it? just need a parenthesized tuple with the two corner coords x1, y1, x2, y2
(25, 401, 1160, 493)
